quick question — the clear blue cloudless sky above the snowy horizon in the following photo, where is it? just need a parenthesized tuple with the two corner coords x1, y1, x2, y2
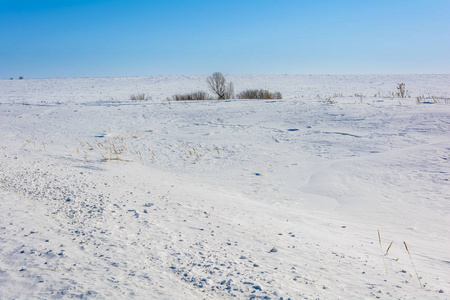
(0, 0, 450, 78)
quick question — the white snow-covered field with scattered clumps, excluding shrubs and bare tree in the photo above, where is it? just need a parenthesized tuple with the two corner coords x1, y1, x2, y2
(0, 75, 450, 299)
